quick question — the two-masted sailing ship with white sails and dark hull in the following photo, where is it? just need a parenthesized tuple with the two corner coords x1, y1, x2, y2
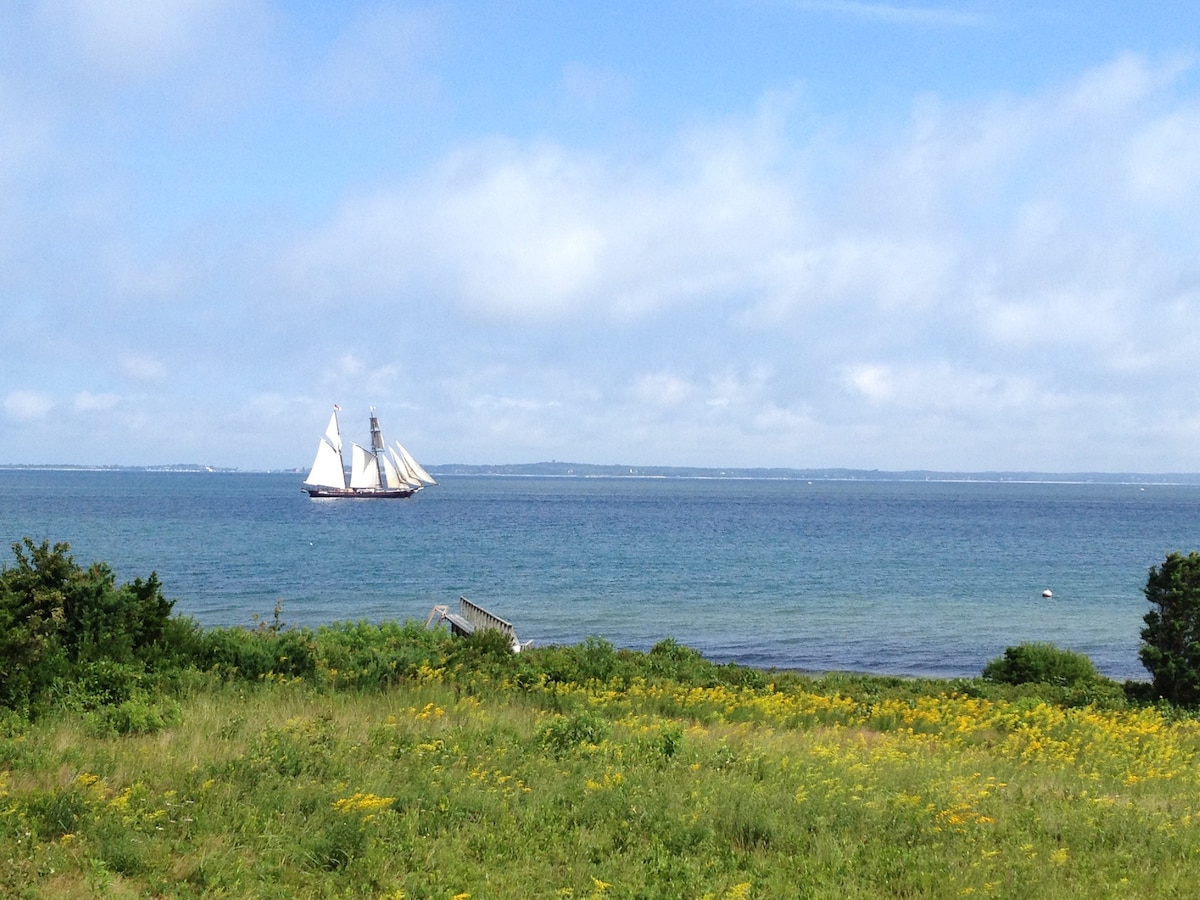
(304, 406, 437, 499)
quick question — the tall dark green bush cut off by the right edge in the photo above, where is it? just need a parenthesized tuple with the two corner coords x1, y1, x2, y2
(1139, 552, 1200, 707)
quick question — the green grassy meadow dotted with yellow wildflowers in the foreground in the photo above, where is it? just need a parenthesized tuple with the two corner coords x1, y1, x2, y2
(0, 625, 1200, 900)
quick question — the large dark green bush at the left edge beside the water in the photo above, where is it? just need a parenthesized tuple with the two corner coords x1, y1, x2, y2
(0, 538, 189, 714)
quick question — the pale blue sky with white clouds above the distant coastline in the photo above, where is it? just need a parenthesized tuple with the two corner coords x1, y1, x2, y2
(0, 0, 1200, 473)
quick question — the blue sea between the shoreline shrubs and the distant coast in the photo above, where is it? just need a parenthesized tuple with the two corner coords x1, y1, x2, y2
(0, 470, 1200, 678)
